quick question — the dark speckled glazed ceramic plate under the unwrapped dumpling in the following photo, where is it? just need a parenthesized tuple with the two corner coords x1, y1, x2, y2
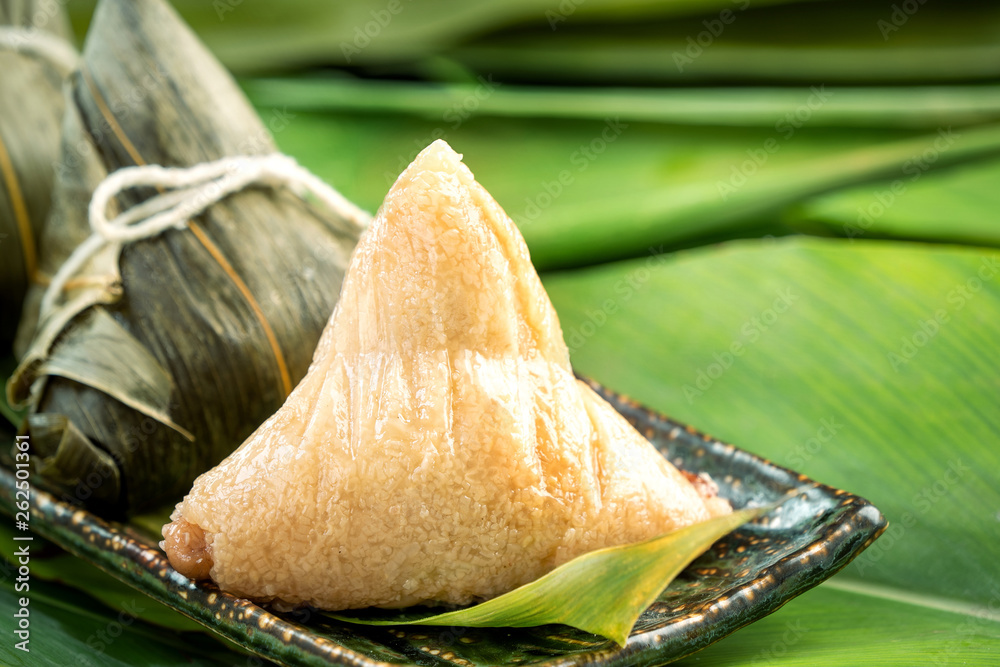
(0, 384, 885, 667)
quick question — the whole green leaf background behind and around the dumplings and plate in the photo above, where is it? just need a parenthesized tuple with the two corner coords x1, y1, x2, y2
(0, 0, 1000, 667)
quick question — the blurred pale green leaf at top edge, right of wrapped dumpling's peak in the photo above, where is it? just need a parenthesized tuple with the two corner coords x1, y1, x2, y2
(68, 0, 812, 72)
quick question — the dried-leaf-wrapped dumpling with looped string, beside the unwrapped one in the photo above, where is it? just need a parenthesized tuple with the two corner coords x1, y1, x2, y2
(8, 0, 363, 512)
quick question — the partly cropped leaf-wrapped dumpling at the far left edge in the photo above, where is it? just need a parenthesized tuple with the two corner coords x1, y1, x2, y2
(0, 0, 72, 354)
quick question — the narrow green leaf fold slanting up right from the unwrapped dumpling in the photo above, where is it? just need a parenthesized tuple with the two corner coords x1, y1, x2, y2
(524, 125, 1000, 272)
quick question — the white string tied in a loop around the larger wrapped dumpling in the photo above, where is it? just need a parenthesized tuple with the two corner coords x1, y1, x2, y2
(41, 153, 371, 314)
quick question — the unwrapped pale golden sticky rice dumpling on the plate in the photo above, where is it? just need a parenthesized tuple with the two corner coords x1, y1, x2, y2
(164, 141, 730, 609)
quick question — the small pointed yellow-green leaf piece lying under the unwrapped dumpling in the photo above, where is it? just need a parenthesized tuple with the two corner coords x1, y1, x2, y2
(332, 507, 770, 646)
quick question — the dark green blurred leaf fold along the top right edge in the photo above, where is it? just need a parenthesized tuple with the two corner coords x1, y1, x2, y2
(445, 1, 1000, 85)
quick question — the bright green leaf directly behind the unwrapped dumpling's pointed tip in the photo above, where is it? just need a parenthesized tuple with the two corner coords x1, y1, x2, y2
(264, 100, 1000, 270)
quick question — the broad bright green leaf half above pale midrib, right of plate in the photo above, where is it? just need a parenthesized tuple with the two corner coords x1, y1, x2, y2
(545, 239, 1000, 603)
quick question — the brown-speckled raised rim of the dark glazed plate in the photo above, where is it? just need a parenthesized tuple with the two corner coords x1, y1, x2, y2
(0, 376, 888, 667)
